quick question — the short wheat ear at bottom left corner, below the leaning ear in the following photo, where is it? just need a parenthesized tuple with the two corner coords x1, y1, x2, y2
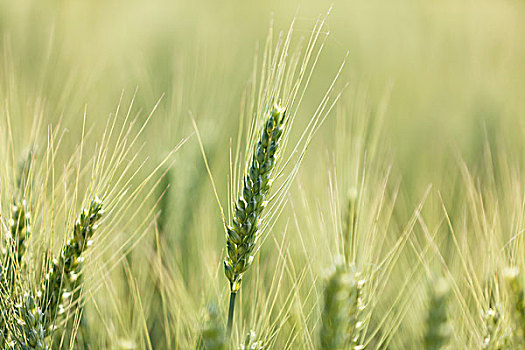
(13, 293, 50, 350)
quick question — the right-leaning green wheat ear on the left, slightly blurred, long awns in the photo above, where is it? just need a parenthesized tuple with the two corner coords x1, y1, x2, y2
(38, 198, 103, 331)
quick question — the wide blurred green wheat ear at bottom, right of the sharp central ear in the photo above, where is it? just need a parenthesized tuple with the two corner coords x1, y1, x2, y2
(319, 264, 364, 350)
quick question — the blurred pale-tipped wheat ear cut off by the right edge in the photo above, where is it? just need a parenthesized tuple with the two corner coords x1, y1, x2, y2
(503, 267, 525, 348)
